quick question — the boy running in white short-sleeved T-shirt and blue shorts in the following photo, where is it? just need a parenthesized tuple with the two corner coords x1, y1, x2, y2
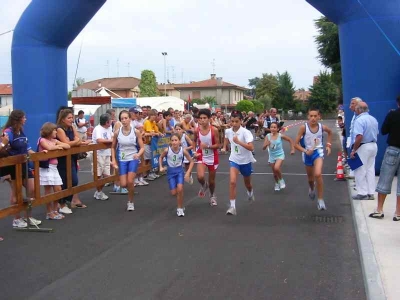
(221, 110, 256, 216)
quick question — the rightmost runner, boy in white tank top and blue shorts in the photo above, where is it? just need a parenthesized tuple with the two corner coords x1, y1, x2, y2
(295, 108, 332, 210)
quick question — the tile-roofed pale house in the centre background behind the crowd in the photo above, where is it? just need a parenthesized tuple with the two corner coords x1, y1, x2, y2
(175, 74, 247, 107)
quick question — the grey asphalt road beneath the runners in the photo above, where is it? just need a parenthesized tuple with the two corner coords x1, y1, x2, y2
(0, 121, 366, 300)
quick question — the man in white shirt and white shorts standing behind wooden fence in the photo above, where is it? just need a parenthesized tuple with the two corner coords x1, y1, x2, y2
(92, 114, 113, 200)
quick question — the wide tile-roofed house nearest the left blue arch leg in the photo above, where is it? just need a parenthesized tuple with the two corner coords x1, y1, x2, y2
(77, 77, 140, 98)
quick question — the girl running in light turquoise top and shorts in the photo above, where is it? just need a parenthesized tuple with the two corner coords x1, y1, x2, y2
(263, 122, 295, 191)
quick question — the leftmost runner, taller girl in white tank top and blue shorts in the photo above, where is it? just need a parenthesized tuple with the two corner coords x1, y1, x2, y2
(111, 110, 144, 211)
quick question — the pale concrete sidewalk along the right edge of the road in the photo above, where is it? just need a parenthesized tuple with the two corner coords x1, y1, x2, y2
(348, 177, 400, 300)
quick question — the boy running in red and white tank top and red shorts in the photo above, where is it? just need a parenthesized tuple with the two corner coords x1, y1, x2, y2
(194, 109, 219, 206)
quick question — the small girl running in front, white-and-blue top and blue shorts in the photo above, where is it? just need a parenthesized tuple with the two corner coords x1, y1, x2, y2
(159, 133, 194, 217)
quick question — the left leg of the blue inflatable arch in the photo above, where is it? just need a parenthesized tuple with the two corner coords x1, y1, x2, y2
(11, 0, 106, 144)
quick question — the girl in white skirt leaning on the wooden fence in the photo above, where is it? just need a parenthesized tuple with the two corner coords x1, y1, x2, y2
(37, 122, 71, 220)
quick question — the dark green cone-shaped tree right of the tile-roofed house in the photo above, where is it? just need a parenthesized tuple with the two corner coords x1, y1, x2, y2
(272, 71, 295, 111)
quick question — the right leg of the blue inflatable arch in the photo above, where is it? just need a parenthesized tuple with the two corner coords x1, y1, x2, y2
(307, 0, 400, 174)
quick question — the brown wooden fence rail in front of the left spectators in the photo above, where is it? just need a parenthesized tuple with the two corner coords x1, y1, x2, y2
(0, 144, 150, 219)
